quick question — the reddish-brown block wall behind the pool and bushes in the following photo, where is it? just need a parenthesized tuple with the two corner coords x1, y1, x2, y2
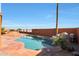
(27, 28, 79, 44)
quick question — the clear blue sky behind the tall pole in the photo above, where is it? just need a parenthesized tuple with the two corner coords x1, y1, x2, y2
(1, 3, 79, 29)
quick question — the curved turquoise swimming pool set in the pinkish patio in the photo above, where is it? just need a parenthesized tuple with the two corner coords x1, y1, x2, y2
(16, 36, 52, 50)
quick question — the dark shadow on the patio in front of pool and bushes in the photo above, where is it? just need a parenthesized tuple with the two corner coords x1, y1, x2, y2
(37, 46, 72, 56)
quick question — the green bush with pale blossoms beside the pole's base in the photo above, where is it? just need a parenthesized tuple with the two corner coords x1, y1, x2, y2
(52, 32, 68, 49)
